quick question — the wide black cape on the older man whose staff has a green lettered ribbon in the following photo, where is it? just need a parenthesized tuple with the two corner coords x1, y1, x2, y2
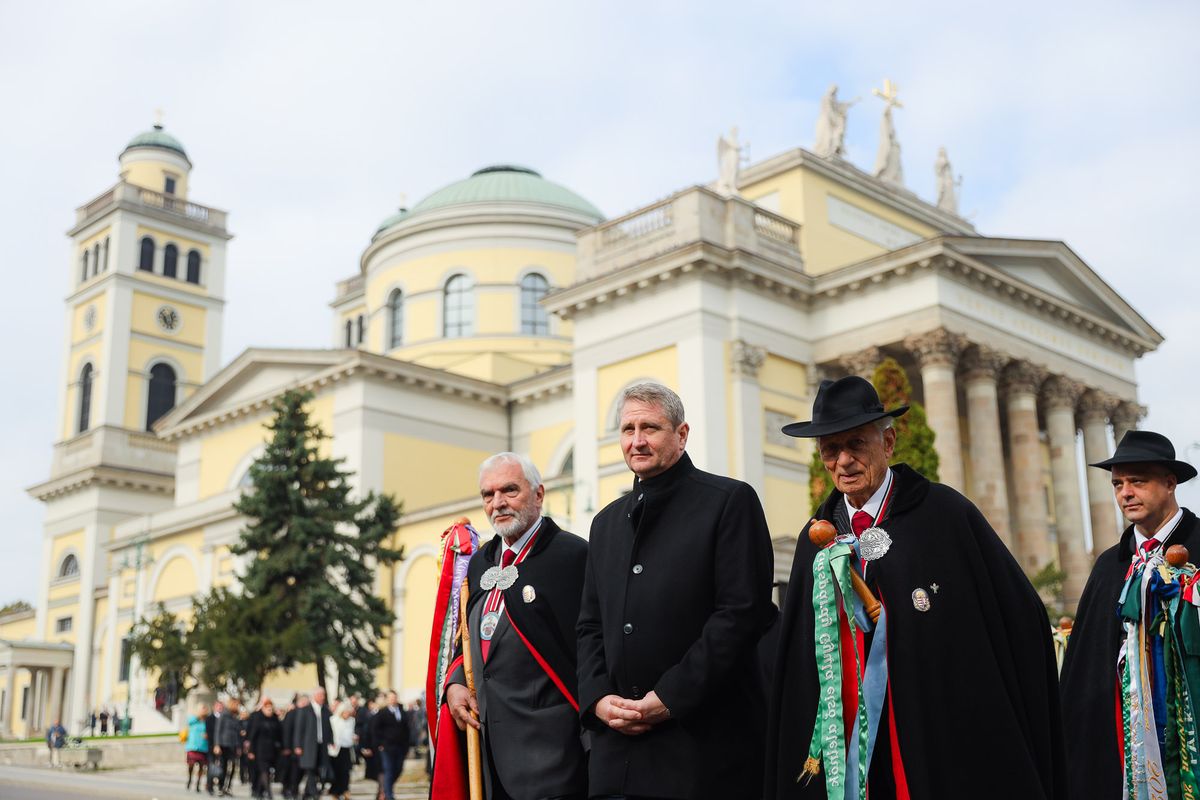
(764, 464, 1066, 800)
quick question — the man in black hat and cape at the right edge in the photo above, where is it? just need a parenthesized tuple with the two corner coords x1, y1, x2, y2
(1062, 431, 1200, 800)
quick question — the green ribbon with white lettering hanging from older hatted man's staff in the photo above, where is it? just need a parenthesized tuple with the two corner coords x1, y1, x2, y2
(796, 542, 868, 800)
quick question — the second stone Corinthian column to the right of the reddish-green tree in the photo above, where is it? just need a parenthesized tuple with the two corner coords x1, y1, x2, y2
(962, 347, 1015, 552)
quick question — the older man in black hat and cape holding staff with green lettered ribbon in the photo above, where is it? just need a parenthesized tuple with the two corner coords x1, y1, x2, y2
(764, 377, 1066, 800)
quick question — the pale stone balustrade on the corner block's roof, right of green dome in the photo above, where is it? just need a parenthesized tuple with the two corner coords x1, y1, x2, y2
(576, 186, 804, 282)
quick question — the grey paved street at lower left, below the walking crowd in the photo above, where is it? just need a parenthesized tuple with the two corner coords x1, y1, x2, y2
(0, 764, 430, 800)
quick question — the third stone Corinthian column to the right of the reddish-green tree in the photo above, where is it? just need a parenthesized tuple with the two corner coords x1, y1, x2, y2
(1003, 361, 1051, 575)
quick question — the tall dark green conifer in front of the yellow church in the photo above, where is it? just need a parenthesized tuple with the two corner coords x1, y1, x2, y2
(232, 391, 403, 692)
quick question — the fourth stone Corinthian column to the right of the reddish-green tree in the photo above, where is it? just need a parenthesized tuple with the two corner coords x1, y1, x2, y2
(1043, 375, 1092, 610)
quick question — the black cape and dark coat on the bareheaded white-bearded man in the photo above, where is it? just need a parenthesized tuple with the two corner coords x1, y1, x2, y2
(449, 517, 588, 800)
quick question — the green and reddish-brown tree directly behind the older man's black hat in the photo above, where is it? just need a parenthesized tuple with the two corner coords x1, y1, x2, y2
(809, 356, 937, 515)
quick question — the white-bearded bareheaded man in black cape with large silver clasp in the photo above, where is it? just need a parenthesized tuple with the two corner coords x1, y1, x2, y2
(446, 452, 588, 800)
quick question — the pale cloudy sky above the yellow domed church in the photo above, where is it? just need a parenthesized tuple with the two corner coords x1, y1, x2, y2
(0, 0, 1200, 604)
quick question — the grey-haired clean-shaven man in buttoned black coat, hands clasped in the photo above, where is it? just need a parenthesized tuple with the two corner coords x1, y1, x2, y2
(578, 383, 773, 800)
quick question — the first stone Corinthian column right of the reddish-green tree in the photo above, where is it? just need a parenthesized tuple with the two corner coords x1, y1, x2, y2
(904, 327, 966, 492)
